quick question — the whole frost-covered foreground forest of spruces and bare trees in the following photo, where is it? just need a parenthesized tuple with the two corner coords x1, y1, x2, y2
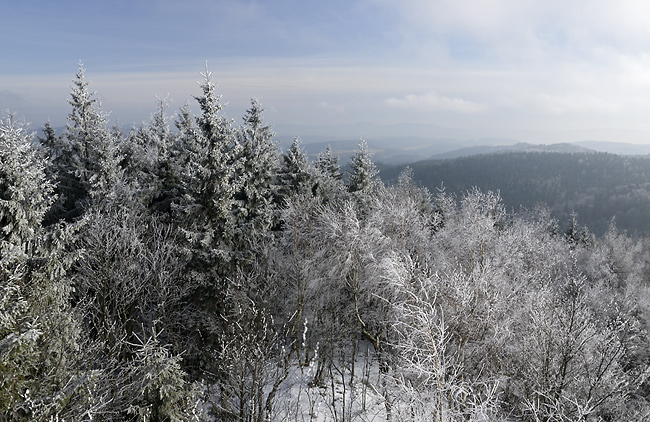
(0, 68, 650, 421)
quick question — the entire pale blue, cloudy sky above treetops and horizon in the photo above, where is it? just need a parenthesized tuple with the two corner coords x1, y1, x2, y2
(0, 0, 650, 143)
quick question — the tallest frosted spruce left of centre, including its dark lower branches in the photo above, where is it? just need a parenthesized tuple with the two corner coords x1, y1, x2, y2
(172, 69, 241, 372)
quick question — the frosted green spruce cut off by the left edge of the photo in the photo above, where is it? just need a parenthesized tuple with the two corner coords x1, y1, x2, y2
(0, 114, 87, 420)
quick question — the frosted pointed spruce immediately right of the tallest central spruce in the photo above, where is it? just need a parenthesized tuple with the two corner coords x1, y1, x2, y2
(234, 99, 279, 263)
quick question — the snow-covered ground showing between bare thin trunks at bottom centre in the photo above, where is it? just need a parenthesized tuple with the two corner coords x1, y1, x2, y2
(197, 344, 470, 422)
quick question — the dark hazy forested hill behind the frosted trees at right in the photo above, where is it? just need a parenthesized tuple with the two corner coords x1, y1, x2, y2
(380, 152, 650, 235)
